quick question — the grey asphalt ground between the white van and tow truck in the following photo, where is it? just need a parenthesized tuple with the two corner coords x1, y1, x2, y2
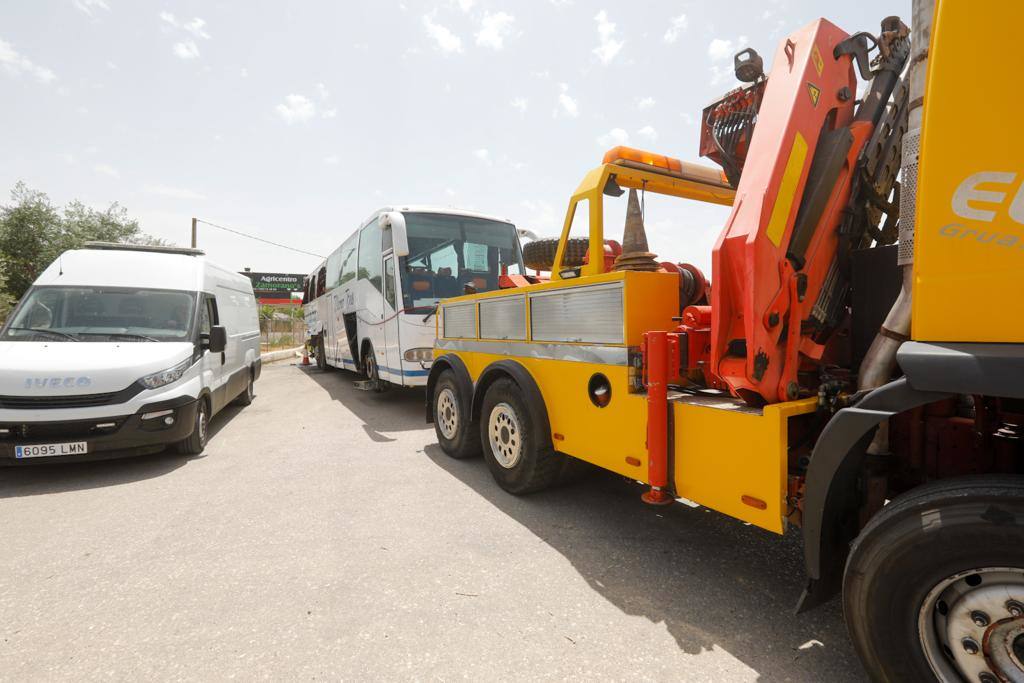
(0, 365, 863, 683)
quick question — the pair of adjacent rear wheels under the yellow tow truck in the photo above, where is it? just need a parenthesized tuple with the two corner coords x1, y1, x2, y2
(432, 370, 565, 495)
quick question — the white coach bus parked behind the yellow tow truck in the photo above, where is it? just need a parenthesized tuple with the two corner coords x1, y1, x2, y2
(303, 207, 524, 389)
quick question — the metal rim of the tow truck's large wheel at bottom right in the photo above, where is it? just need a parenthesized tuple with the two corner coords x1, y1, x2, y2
(918, 567, 1024, 683)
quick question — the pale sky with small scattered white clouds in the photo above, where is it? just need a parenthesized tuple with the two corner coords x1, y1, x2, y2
(0, 0, 909, 272)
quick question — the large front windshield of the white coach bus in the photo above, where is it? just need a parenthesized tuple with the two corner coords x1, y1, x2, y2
(401, 213, 523, 312)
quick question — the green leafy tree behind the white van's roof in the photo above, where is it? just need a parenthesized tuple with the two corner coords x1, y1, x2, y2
(0, 182, 166, 300)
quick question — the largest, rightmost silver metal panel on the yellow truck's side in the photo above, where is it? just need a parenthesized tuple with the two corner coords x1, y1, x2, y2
(529, 283, 625, 344)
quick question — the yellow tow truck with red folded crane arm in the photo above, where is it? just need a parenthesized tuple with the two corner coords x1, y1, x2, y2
(427, 0, 1024, 683)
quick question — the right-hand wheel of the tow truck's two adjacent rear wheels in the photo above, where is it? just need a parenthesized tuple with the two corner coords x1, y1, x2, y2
(480, 378, 563, 495)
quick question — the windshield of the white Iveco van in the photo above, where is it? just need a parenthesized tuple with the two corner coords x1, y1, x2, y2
(0, 287, 196, 342)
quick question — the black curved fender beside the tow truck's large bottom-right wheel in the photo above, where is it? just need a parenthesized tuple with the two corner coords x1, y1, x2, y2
(797, 377, 950, 612)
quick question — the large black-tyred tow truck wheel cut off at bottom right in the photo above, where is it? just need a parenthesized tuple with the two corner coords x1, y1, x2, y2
(843, 475, 1024, 683)
